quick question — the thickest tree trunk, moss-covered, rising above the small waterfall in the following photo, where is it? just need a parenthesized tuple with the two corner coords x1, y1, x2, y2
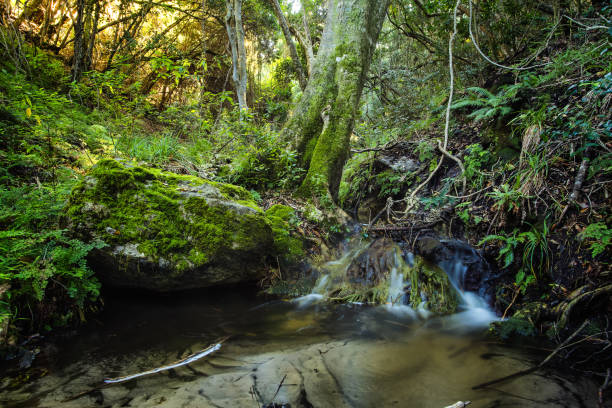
(283, 0, 388, 199)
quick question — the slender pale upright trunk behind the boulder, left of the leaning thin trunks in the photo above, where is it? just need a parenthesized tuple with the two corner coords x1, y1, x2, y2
(225, 0, 249, 112)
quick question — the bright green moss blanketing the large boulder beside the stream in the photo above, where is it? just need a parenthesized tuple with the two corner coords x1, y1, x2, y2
(67, 160, 278, 272)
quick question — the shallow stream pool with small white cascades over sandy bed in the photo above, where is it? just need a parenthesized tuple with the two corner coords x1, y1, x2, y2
(0, 241, 596, 408)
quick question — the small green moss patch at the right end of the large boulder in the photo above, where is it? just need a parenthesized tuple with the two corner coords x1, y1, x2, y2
(266, 204, 304, 262)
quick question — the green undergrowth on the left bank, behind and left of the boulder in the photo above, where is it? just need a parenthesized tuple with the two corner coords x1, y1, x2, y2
(0, 27, 303, 344)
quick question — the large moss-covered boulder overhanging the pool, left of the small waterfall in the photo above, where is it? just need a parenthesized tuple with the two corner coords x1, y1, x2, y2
(67, 160, 297, 291)
